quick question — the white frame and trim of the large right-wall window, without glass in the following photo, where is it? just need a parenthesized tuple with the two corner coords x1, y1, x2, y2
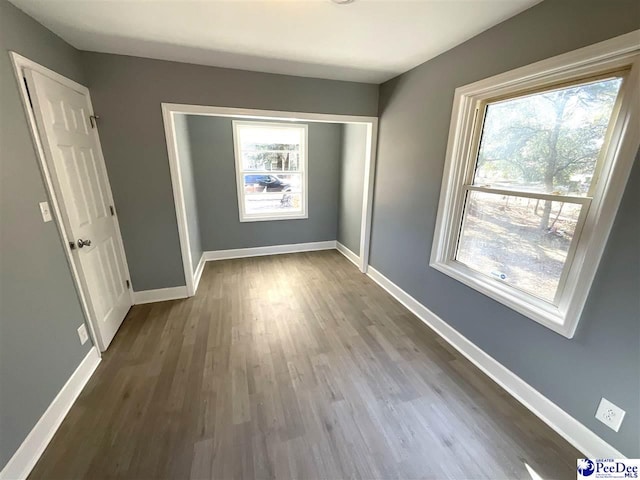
(430, 30, 640, 338)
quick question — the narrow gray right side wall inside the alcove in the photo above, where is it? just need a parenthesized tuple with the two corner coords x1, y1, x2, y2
(338, 123, 367, 255)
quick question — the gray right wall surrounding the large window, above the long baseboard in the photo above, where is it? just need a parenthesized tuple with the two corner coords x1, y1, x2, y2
(371, 0, 640, 457)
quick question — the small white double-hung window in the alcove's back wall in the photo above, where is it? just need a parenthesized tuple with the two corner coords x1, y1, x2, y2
(233, 121, 308, 222)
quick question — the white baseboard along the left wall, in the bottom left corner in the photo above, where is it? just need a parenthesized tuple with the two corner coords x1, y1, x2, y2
(0, 347, 100, 480)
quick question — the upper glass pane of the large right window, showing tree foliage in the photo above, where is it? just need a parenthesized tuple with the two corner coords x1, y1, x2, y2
(474, 78, 622, 196)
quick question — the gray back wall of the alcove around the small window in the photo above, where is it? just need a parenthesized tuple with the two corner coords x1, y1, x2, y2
(188, 115, 342, 251)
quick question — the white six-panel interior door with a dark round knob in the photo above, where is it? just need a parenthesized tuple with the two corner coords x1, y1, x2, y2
(24, 69, 132, 351)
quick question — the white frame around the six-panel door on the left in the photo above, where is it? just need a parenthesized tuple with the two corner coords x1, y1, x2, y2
(9, 51, 133, 355)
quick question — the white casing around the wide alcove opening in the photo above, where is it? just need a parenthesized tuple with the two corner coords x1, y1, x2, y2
(162, 103, 378, 296)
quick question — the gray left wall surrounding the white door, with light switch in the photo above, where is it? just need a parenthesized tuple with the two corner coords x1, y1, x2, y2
(0, 0, 91, 470)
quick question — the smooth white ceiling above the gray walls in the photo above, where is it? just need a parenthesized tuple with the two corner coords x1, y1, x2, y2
(11, 0, 541, 83)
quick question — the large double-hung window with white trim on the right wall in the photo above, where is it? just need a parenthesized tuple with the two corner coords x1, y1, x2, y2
(431, 36, 638, 337)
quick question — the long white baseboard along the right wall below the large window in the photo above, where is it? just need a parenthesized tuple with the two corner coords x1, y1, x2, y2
(367, 266, 625, 458)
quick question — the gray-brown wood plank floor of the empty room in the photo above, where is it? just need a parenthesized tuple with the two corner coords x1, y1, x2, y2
(30, 251, 582, 479)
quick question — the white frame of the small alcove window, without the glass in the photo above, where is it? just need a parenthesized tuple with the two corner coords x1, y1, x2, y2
(233, 120, 309, 222)
